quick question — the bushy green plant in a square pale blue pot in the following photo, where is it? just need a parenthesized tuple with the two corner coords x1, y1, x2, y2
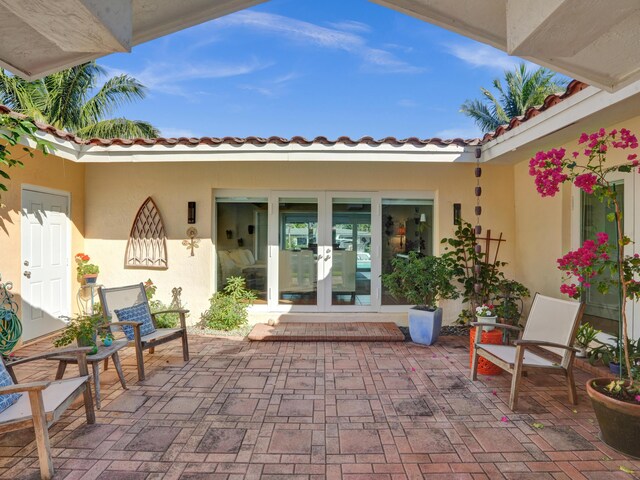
(382, 252, 458, 345)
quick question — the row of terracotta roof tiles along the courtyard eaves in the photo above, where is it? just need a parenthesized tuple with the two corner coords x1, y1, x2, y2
(0, 80, 588, 147)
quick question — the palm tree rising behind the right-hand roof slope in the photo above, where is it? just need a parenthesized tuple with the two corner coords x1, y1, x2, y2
(460, 63, 567, 133)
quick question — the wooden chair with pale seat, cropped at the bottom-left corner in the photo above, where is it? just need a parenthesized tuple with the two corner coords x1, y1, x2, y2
(0, 347, 96, 480)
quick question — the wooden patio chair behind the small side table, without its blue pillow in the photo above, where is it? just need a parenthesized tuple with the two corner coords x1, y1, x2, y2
(98, 283, 189, 380)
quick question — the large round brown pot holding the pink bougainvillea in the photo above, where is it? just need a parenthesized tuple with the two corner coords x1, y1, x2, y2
(587, 378, 640, 458)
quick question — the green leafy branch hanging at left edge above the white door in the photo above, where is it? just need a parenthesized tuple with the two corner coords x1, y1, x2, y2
(0, 114, 53, 207)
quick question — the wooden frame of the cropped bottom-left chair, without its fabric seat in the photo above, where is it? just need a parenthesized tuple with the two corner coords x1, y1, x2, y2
(0, 347, 96, 480)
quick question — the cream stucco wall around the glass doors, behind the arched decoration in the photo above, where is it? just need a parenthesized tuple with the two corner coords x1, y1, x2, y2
(85, 162, 515, 322)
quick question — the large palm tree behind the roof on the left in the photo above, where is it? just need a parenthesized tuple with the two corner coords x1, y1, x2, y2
(0, 62, 159, 138)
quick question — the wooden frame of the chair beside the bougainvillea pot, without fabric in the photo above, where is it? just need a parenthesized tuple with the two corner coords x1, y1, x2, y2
(471, 293, 585, 411)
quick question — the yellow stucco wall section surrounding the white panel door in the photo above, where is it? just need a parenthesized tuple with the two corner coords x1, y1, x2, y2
(0, 147, 85, 316)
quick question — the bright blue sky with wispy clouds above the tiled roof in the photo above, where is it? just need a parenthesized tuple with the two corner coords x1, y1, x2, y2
(99, 0, 544, 138)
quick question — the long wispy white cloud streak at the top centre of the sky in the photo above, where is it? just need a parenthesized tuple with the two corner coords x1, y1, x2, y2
(214, 10, 423, 73)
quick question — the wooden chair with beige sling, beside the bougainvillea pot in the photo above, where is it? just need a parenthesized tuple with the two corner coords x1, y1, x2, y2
(471, 294, 584, 410)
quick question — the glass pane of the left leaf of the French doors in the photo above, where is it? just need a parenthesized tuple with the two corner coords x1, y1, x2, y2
(278, 198, 318, 305)
